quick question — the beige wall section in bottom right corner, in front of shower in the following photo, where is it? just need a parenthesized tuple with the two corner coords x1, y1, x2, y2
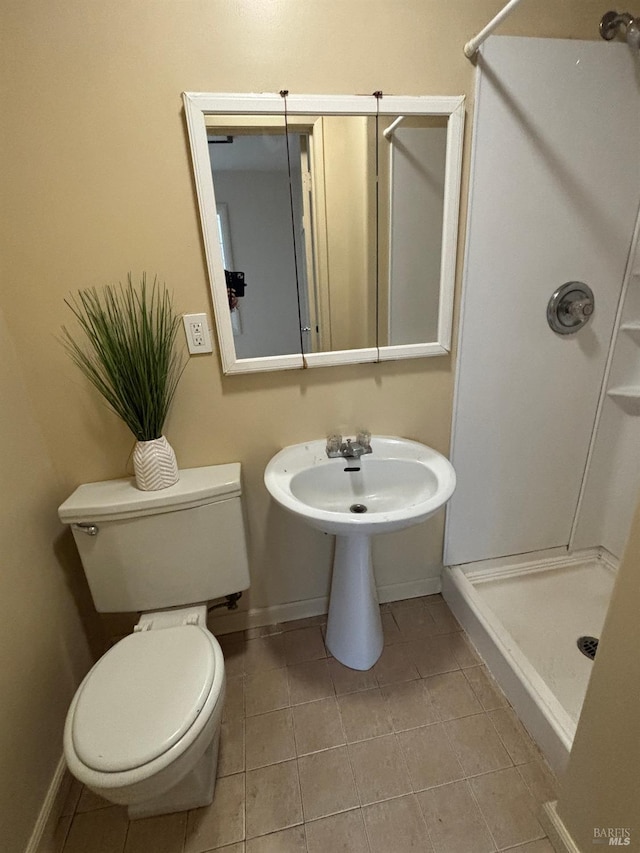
(557, 496, 640, 853)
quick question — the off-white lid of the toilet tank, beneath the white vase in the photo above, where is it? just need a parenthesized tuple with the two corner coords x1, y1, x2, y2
(58, 462, 241, 524)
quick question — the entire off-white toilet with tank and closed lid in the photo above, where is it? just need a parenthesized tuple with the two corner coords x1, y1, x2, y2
(58, 463, 249, 819)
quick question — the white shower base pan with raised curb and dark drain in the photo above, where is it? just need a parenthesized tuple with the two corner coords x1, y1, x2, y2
(442, 549, 616, 775)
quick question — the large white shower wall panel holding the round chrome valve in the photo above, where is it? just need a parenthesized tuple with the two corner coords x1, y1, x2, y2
(445, 37, 640, 565)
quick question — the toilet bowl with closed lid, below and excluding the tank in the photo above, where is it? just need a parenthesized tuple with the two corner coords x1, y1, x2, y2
(64, 607, 225, 818)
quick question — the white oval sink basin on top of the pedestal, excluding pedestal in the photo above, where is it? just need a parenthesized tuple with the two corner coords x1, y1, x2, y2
(264, 436, 456, 535)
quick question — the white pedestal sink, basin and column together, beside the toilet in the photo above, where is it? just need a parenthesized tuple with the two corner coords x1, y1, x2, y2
(264, 436, 456, 670)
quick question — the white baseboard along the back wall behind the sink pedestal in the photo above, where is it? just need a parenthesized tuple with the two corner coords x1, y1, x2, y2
(209, 575, 442, 634)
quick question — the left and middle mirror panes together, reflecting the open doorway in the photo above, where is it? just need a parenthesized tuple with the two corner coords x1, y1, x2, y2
(208, 115, 377, 359)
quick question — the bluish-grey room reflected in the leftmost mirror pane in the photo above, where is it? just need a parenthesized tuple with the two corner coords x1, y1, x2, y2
(209, 128, 310, 358)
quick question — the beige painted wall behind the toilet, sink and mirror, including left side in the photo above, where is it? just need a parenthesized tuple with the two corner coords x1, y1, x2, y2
(0, 0, 603, 851)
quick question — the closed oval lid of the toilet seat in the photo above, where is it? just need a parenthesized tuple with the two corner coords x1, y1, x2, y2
(71, 625, 215, 772)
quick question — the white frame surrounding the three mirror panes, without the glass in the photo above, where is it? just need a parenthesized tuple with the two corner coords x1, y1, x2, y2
(183, 92, 464, 374)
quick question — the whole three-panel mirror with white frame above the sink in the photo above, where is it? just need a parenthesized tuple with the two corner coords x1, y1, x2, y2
(183, 92, 464, 374)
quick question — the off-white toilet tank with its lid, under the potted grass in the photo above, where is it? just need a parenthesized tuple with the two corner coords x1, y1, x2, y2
(58, 462, 249, 613)
